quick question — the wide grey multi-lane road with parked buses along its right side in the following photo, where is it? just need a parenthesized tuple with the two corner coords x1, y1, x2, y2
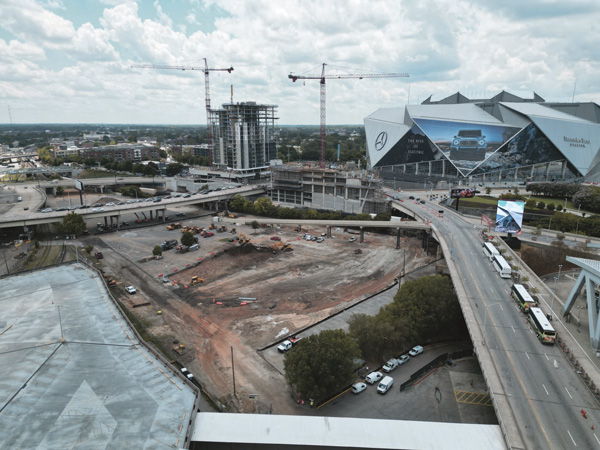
(398, 194, 600, 449)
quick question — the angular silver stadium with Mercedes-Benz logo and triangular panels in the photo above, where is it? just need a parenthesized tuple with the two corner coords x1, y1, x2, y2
(364, 91, 600, 184)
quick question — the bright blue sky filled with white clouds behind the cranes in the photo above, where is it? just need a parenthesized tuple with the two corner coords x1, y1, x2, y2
(0, 0, 600, 125)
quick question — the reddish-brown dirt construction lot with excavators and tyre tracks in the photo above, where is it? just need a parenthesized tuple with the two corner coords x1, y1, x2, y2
(94, 217, 433, 414)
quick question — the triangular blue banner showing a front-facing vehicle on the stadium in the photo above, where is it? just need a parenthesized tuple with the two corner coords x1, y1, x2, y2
(414, 119, 520, 175)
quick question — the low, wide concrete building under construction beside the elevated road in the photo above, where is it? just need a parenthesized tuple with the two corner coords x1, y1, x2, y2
(271, 166, 390, 214)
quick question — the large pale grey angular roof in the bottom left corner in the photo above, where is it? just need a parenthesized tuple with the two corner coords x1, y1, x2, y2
(0, 264, 197, 449)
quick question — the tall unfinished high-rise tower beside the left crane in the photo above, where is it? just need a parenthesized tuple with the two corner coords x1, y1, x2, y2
(210, 102, 278, 175)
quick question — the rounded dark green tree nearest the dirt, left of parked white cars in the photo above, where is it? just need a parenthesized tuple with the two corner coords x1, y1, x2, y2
(283, 330, 361, 400)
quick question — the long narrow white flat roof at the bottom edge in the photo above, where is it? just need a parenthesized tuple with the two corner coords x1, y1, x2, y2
(191, 412, 506, 450)
